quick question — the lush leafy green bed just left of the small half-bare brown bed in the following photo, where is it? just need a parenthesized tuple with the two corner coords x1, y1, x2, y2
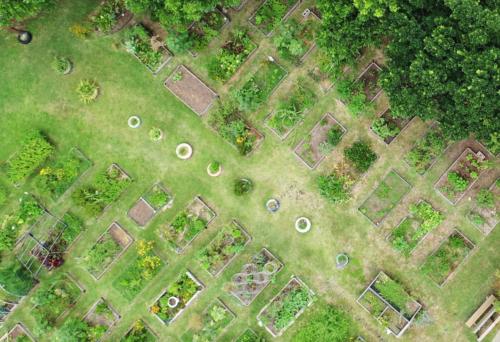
(72, 164, 132, 216)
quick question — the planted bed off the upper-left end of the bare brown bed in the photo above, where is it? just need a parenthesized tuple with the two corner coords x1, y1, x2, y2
(123, 24, 172, 75)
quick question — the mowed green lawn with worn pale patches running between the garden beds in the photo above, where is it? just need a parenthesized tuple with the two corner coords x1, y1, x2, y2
(0, 1, 500, 341)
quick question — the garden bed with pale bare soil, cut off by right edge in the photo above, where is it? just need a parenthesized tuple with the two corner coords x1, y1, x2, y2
(467, 178, 500, 235)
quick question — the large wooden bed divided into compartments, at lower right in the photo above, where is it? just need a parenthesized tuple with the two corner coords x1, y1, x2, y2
(356, 272, 422, 337)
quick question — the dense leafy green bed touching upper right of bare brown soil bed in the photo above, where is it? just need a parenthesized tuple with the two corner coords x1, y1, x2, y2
(208, 28, 257, 82)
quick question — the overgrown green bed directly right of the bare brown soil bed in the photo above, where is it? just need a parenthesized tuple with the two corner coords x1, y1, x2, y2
(233, 57, 287, 112)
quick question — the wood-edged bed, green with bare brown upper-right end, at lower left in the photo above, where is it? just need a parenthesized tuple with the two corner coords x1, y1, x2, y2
(82, 222, 134, 280)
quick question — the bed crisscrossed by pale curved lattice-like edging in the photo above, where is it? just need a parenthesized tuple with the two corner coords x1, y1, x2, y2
(229, 248, 283, 306)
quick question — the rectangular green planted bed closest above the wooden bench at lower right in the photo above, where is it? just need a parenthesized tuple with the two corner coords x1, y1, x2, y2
(421, 229, 475, 287)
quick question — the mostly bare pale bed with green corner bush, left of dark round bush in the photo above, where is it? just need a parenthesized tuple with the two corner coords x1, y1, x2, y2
(293, 113, 347, 169)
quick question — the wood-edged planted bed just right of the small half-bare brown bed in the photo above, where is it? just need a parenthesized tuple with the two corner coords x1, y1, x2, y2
(163, 196, 216, 253)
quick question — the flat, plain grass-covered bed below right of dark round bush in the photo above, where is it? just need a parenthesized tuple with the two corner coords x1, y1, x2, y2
(359, 170, 411, 226)
